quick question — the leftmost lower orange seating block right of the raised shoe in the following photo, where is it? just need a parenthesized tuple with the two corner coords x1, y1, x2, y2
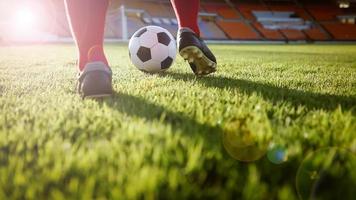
(217, 21, 260, 40)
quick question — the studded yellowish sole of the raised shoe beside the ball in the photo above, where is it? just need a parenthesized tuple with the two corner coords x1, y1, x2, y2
(179, 46, 216, 76)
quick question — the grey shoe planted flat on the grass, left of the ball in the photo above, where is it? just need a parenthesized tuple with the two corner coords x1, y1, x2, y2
(78, 62, 112, 98)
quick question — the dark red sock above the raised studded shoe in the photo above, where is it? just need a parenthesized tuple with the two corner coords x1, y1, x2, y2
(171, 0, 200, 35)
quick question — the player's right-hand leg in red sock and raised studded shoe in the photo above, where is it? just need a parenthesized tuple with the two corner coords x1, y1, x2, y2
(171, 0, 216, 75)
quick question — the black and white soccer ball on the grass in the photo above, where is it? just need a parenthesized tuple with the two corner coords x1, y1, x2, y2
(129, 26, 177, 73)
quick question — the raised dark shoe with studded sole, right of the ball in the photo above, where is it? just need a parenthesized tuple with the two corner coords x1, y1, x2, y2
(177, 28, 217, 76)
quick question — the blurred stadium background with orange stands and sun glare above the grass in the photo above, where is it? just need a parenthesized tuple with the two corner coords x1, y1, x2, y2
(0, 0, 356, 43)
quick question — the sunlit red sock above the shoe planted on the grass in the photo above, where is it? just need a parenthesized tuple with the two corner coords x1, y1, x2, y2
(65, 0, 109, 71)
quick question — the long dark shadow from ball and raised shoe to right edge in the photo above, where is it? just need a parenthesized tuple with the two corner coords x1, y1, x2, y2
(161, 72, 356, 112)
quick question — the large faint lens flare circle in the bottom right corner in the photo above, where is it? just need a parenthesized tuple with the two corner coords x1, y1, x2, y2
(296, 147, 356, 199)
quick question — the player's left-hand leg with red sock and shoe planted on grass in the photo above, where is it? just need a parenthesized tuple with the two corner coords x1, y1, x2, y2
(65, 0, 112, 97)
